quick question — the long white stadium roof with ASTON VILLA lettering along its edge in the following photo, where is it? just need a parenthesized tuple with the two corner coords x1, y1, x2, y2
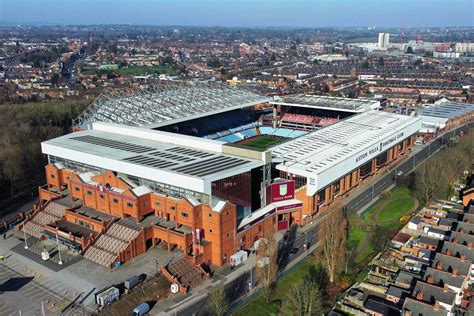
(272, 111, 421, 195)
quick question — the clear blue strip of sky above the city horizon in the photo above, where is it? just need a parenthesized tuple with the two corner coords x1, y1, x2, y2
(0, 0, 474, 27)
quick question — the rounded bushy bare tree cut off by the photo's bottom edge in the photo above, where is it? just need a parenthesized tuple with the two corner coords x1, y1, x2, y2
(282, 281, 323, 316)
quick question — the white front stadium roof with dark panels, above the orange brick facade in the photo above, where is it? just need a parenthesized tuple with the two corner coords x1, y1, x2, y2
(41, 123, 263, 194)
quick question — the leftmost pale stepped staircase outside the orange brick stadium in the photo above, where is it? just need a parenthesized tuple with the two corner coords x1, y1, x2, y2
(23, 201, 67, 239)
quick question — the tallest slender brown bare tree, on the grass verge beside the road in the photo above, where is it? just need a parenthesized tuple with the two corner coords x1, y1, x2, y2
(319, 203, 347, 283)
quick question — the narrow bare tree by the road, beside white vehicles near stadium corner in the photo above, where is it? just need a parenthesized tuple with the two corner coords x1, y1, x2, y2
(256, 237, 278, 303)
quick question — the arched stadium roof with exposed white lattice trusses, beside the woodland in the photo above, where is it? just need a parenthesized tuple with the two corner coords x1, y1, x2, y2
(74, 82, 270, 129)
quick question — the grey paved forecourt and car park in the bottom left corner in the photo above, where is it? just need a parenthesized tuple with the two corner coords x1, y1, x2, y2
(0, 231, 181, 316)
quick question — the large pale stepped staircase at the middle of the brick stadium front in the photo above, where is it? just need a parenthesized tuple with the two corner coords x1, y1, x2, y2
(83, 219, 142, 268)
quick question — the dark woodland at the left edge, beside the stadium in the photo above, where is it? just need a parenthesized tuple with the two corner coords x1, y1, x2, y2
(0, 99, 90, 201)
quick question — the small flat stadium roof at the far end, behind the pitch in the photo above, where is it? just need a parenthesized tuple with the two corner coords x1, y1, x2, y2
(270, 94, 380, 113)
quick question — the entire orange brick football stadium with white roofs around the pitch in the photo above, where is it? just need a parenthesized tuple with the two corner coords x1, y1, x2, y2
(23, 82, 421, 288)
